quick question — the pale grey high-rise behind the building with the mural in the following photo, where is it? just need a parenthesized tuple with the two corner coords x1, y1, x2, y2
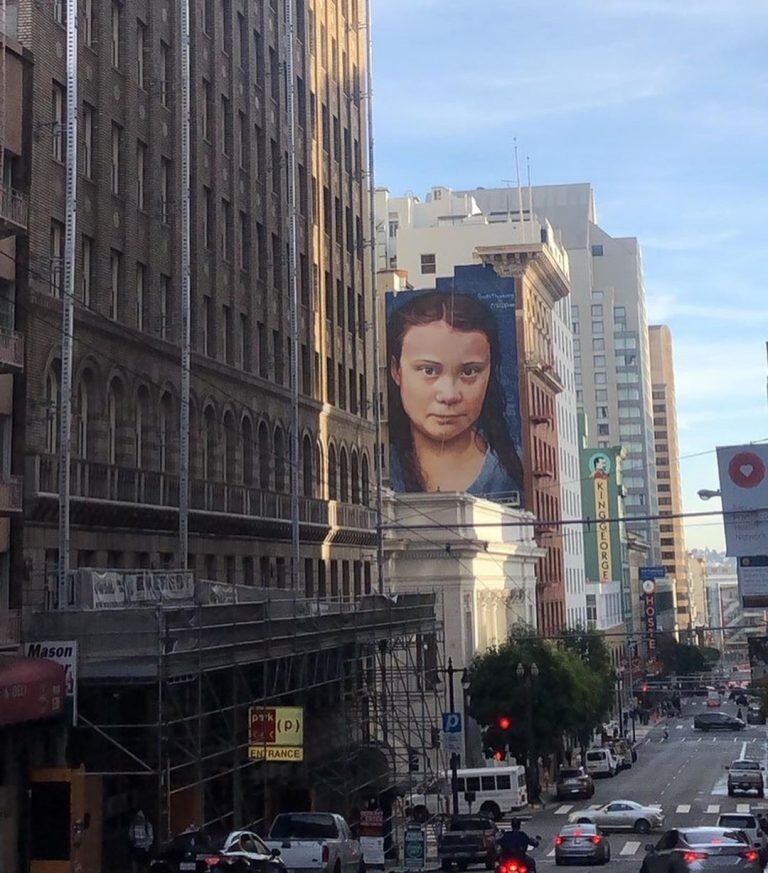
(458, 183, 663, 564)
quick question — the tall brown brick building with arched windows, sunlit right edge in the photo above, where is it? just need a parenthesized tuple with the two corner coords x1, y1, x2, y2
(17, 0, 375, 606)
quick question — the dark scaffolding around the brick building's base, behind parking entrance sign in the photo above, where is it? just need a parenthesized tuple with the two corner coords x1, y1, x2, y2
(30, 571, 446, 870)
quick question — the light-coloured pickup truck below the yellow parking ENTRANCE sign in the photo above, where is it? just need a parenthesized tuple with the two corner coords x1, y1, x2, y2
(265, 812, 365, 873)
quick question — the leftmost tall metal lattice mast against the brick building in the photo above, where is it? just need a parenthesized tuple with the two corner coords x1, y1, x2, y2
(54, 0, 80, 607)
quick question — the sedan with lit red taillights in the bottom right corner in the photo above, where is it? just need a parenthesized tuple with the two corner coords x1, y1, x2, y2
(640, 827, 763, 873)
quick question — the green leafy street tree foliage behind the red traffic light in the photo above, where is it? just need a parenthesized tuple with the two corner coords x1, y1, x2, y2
(469, 628, 614, 760)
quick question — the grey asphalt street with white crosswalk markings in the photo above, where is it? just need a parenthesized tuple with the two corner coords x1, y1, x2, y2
(524, 699, 768, 873)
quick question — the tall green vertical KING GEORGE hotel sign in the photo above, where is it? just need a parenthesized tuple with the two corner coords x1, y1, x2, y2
(581, 448, 624, 582)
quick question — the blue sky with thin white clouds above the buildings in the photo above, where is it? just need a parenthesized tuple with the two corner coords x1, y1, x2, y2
(374, 0, 768, 548)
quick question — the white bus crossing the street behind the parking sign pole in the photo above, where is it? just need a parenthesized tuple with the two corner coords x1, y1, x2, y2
(406, 764, 528, 822)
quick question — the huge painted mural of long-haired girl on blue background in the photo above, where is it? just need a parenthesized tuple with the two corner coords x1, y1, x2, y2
(386, 265, 524, 505)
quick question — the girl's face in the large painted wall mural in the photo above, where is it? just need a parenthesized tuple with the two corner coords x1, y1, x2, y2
(391, 321, 491, 441)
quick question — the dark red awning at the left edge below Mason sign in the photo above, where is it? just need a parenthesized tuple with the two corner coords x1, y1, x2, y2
(0, 655, 65, 725)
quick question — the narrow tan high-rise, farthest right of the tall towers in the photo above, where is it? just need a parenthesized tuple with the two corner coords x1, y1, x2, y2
(648, 324, 695, 628)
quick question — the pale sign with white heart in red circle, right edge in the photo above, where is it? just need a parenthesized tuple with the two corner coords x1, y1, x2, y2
(717, 445, 768, 558)
